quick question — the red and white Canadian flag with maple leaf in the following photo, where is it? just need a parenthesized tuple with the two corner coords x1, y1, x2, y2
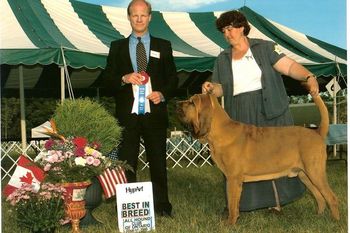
(4, 155, 44, 197)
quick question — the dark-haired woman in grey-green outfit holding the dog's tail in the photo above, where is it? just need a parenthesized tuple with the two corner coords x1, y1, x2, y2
(202, 10, 319, 211)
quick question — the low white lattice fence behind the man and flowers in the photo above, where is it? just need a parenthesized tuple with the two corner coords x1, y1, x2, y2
(1, 136, 212, 180)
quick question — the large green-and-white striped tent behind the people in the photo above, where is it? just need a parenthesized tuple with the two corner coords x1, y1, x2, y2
(0, 0, 347, 96)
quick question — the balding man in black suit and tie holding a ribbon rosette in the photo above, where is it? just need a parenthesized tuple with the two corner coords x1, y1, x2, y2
(103, 0, 178, 216)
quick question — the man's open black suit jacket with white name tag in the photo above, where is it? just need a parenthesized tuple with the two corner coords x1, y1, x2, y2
(103, 36, 178, 127)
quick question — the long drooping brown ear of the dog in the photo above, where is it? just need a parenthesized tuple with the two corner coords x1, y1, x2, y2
(192, 94, 212, 138)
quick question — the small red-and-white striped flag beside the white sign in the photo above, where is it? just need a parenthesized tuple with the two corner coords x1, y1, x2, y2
(97, 167, 128, 199)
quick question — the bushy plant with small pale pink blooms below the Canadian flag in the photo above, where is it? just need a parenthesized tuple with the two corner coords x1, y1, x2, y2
(6, 183, 65, 232)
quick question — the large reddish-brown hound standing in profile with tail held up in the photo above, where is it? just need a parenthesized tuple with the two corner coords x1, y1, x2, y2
(177, 94, 339, 224)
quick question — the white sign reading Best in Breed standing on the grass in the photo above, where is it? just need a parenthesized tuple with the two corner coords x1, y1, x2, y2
(116, 182, 155, 232)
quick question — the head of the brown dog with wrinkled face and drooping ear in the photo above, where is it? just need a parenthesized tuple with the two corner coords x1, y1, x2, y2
(177, 94, 216, 139)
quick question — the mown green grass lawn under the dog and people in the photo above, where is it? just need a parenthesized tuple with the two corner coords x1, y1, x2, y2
(2, 161, 348, 233)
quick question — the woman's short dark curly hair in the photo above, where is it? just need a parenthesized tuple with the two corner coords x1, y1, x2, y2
(216, 10, 250, 36)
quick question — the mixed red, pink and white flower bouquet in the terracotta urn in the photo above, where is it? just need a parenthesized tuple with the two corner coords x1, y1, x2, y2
(34, 136, 116, 183)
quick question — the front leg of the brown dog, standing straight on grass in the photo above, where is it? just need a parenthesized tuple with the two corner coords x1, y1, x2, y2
(226, 177, 242, 224)
